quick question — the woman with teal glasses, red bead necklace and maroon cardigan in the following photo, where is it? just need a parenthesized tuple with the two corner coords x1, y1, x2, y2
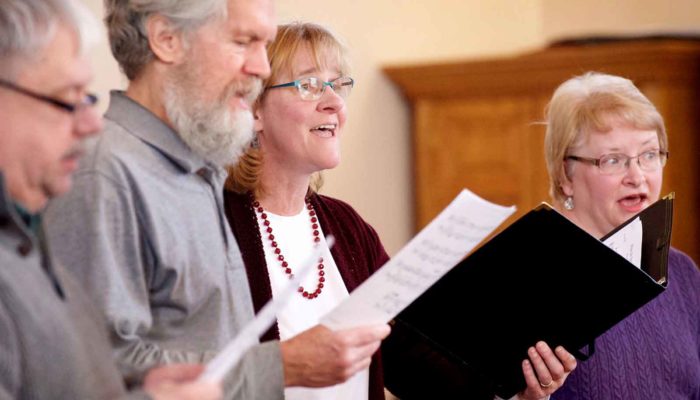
(224, 23, 575, 400)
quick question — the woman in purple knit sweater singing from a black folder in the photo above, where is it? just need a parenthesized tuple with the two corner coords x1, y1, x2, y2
(545, 73, 700, 400)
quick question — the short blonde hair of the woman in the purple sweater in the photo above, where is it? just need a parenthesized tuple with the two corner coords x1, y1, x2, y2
(544, 72, 668, 202)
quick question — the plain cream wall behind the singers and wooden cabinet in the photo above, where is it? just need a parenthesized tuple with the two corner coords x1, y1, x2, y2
(83, 0, 700, 253)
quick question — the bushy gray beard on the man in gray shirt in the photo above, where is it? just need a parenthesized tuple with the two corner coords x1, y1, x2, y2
(165, 80, 260, 167)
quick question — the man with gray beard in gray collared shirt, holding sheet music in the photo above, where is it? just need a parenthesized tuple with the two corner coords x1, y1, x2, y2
(47, 0, 389, 400)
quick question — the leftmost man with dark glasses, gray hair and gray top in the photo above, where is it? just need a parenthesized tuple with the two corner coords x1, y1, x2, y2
(0, 0, 221, 399)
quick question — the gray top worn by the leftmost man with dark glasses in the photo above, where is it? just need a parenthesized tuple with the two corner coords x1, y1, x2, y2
(0, 173, 147, 400)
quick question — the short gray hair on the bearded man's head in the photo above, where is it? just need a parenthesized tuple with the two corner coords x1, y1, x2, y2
(105, 0, 228, 80)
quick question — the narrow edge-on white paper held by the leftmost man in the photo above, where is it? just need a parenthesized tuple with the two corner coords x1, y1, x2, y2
(198, 235, 335, 382)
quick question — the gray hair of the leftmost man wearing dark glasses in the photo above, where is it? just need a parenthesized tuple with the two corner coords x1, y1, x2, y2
(0, 0, 100, 80)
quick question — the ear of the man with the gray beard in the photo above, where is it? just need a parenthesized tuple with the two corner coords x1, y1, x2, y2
(146, 14, 186, 64)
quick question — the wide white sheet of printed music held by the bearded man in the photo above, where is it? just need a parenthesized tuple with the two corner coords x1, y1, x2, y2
(321, 189, 515, 330)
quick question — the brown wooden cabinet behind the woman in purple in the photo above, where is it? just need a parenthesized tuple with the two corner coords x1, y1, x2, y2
(385, 40, 700, 262)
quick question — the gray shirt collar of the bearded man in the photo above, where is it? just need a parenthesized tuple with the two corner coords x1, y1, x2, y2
(105, 90, 213, 173)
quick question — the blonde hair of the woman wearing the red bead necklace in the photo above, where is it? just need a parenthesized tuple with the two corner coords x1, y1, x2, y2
(226, 22, 350, 196)
